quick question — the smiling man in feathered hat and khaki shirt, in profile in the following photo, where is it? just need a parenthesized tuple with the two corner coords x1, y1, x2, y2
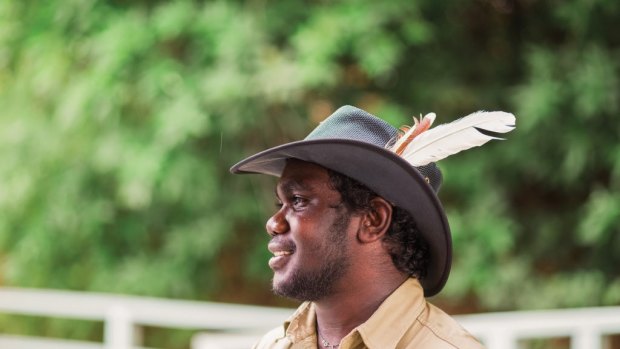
(231, 106, 514, 349)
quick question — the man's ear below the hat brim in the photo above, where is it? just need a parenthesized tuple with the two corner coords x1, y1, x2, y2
(357, 197, 392, 243)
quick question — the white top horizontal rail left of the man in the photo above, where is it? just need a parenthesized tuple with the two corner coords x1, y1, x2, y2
(0, 287, 291, 330)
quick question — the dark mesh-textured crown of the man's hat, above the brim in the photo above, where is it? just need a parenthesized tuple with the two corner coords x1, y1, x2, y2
(305, 105, 398, 147)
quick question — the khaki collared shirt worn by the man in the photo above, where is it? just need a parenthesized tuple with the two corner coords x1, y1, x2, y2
(254, 278, 484, 349)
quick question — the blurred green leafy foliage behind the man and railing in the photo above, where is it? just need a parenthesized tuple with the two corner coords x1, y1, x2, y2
(0, 0, 620, 348)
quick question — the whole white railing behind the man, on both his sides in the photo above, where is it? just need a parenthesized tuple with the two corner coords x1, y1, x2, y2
(0, 288, 620, 349)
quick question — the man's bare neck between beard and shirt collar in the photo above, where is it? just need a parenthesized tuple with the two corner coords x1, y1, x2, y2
(314, 276, 407, 344)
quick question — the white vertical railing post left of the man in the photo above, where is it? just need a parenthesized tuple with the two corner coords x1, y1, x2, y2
(103, 306, 134, 349)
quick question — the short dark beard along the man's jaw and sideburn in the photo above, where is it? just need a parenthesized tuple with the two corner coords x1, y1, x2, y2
(273, 213, 350, 301)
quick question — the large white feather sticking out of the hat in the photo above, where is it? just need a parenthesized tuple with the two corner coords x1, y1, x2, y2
(400, 111, 515, 166)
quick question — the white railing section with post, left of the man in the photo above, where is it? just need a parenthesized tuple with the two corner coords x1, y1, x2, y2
(0, 288, 291, 349)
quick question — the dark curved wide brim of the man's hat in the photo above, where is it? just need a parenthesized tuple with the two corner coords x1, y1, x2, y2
(230, 139, 452, 297)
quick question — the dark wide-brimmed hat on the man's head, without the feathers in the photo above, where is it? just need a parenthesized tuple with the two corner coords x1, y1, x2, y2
(230, 106, 452, 297)
